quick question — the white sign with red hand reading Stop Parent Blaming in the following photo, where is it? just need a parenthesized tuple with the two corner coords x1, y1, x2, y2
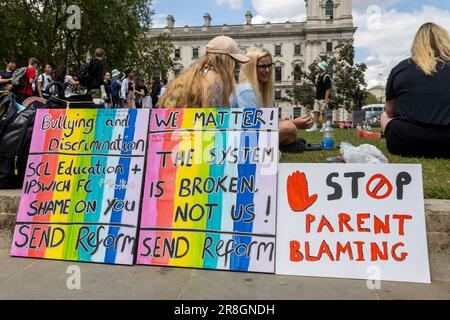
(276, 164, 430, 283)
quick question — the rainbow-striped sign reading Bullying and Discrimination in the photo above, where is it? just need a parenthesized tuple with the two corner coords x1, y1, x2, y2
(11, 110, 149, 265)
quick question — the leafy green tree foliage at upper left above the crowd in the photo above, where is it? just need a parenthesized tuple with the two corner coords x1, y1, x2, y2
(0, 0, 174, 79)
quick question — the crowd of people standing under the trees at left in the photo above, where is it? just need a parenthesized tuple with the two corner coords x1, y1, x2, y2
(0, 48, 167, 108)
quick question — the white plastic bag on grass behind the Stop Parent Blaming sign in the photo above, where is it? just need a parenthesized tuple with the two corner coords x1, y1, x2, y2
(341, 142, 389, 164)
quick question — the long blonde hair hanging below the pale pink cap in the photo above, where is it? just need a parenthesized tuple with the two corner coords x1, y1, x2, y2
(158, 53, 236, 108)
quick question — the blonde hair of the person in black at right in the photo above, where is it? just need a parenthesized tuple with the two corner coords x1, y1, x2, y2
(411, 22, 450, 76)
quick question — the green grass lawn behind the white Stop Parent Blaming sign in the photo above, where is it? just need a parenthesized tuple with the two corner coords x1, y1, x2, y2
(281, 129, 450, 199)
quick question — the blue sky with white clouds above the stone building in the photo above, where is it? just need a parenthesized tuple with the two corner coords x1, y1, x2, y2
(153, 0, 450, 88)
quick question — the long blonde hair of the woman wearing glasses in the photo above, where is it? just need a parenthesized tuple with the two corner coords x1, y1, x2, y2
(239, 47, 275, 107)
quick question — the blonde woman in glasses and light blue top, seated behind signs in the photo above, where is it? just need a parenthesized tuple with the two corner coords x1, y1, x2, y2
(231, 47, 313, 153)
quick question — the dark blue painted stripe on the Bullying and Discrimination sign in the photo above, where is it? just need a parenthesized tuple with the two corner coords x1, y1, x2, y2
(105, 109, 138, 264)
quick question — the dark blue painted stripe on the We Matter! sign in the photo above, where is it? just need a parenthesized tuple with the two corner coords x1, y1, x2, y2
(231, 109, 260, 271)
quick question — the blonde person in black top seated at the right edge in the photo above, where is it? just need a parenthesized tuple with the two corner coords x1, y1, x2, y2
(381, 23, 450, 158)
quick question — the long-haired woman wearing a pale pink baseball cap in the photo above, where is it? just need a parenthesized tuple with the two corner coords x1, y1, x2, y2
(158, 36, 249, 108)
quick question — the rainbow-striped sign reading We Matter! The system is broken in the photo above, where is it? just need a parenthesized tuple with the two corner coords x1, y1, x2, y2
(137, 109, 278, 273)
